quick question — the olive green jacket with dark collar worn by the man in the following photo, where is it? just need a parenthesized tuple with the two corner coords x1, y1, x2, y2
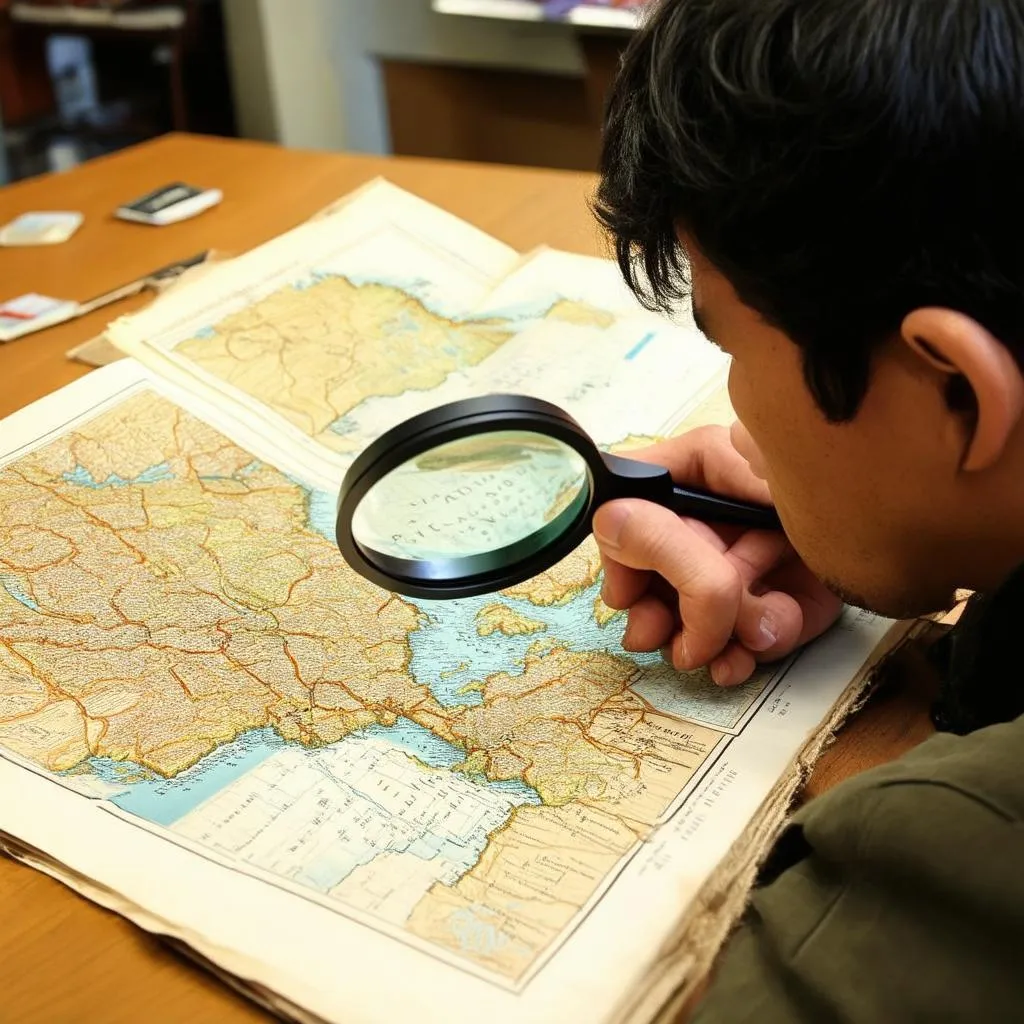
(692, 587, 1024, 1024)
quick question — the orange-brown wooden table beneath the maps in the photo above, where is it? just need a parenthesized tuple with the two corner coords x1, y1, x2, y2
(0, 135, 931, 1024)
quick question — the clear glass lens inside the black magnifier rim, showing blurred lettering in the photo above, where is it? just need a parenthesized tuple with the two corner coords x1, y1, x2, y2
(352, 430, 589, 574)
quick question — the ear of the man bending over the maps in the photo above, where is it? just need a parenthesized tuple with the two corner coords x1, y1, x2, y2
(900, 308, 1024, 472)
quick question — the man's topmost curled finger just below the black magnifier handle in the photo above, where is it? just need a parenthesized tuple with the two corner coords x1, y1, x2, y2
(594, 500, 743, 669)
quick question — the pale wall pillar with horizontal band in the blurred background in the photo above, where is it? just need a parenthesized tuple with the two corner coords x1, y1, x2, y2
(224, 0, 584, 153)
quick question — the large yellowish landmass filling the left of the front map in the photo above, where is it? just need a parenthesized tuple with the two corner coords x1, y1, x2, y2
(0, 394, 440, 775)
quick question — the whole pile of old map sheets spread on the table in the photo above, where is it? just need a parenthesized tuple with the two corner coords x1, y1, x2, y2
(0, 182, 913, 1024)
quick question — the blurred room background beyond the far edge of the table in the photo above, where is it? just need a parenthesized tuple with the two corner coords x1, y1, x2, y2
(0, 0, 643, 180)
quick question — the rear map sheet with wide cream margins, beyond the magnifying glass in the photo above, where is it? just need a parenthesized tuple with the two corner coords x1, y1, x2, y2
(110, 183, 725, 462)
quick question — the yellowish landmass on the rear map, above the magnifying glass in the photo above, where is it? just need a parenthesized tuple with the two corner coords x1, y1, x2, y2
(175, 276, 520, 452)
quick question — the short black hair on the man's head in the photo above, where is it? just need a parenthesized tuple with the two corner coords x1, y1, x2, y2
(595, 0, 1024, 420)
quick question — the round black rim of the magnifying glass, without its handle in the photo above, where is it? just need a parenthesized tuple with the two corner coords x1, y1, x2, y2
(336, 394, 608, 599)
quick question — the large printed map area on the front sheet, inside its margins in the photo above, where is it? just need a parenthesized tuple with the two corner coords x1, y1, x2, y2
(0, 392, 764, 981)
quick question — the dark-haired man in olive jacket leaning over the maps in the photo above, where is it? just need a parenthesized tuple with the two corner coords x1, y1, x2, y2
(594, 0, 1024, 1024)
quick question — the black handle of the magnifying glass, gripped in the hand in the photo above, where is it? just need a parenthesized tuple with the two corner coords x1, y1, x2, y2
(599, 453, 782, 529)
